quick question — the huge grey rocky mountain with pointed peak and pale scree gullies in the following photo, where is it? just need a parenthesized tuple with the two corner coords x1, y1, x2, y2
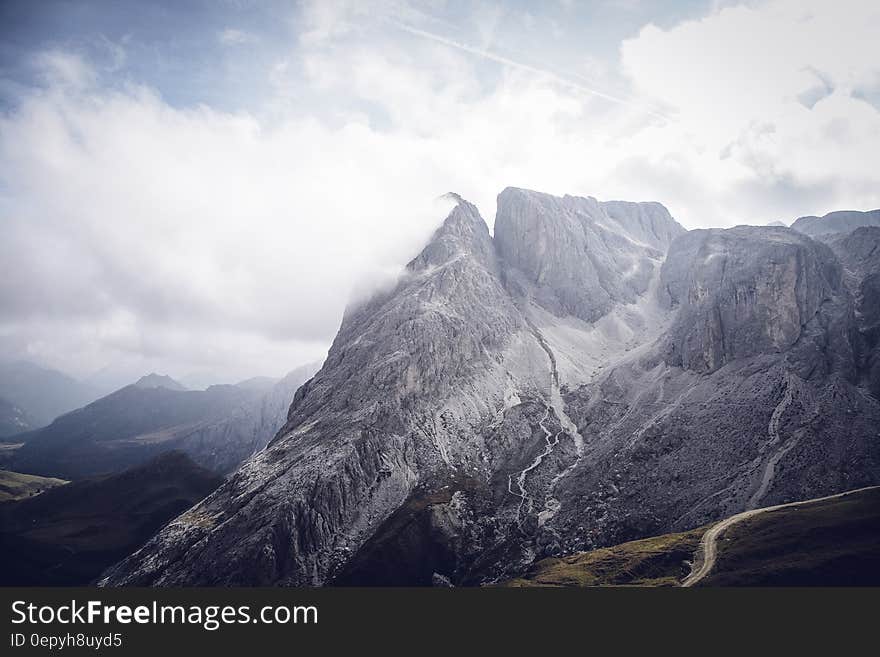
(101, 188, 880, 586)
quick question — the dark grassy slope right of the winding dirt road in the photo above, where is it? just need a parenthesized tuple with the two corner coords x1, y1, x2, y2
(701, 489, 880, 586)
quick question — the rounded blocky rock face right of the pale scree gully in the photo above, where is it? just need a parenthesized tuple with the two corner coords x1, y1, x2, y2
(660, 226, 852, 376)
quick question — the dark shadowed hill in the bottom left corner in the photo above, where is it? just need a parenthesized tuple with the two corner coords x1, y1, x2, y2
(0, 452, 221, 586)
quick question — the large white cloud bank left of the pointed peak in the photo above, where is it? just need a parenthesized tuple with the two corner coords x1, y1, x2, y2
(0, 65, 445, 375)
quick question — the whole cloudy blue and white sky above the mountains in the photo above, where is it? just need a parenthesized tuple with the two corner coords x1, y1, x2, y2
(0, 0, 880, 385)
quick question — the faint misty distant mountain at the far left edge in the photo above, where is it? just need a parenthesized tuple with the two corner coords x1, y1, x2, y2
(0, 361, 100, 427)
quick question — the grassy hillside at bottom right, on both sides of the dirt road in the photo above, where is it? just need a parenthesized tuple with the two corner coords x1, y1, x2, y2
(501, 489, 880, 587)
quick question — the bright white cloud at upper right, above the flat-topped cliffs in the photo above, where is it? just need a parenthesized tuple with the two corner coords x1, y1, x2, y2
(622, 0, 880, 222)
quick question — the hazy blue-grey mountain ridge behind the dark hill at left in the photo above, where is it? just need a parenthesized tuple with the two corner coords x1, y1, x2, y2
(8, 365, 317, 479)
